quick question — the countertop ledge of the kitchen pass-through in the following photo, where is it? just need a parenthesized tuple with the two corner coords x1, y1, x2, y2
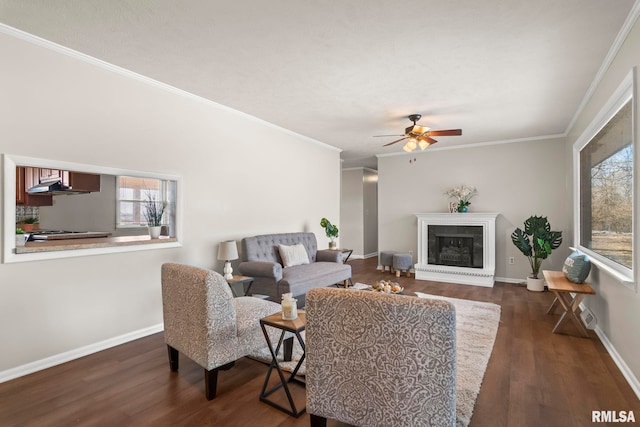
(16, 235, 178, 254)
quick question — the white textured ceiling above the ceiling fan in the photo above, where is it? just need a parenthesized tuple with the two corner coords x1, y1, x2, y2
(0, 0, 634, 168)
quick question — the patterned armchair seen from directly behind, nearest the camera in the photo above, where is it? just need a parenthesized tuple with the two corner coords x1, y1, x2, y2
(305, 288, 456, 427)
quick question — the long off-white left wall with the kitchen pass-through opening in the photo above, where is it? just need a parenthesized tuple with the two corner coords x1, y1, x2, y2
(0, 27, 340, 378)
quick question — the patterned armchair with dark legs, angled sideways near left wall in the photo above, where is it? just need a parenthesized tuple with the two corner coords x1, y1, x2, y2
(162, 263, 281, 400)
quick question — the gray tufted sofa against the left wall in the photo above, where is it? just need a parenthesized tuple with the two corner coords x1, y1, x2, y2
(238, 233, 351, 307)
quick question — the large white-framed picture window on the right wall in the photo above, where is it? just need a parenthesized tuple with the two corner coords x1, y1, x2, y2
(574, 72, 635, 285)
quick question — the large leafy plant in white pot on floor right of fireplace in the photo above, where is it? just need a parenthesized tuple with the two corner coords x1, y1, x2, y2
(511, 216, 562, 292)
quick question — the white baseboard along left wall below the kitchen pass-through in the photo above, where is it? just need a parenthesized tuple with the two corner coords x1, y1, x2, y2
(0, 323, 164, 383)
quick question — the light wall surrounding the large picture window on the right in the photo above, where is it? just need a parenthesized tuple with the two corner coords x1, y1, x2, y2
(566, 12, 640, 388)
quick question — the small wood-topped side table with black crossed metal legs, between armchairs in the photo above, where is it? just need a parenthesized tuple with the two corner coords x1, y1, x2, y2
(260, 310, 307, 418)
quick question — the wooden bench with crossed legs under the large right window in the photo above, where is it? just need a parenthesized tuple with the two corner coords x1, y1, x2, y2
(542, 270, 596, 338)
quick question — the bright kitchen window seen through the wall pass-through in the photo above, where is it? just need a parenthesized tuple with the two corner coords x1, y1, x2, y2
(116, 176, 175, 228)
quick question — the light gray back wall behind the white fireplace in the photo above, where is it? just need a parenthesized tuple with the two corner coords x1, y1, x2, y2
(378, 139, 571, 282)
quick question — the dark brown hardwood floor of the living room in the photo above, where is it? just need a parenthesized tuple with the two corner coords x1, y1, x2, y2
(0, 258, 640, 427)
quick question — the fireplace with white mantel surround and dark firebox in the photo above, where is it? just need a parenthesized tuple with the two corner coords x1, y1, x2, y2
(415, 213, 498, 287)
